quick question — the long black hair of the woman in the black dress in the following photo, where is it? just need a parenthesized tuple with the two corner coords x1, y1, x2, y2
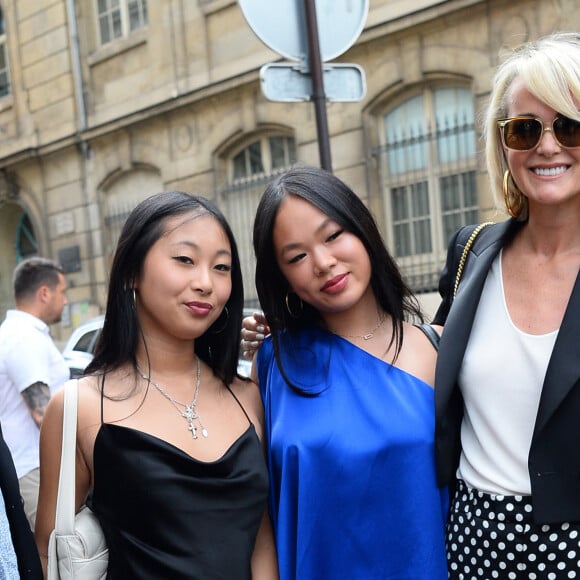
(86, 191, 244, 384)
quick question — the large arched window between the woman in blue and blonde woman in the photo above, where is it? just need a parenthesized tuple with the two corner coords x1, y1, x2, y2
(380, 87, 478, 291)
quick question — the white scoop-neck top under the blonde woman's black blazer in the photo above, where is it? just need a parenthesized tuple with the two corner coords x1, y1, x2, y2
(457, 252, 558, 495)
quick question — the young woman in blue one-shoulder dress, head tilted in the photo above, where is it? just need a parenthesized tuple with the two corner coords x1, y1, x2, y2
(247, 167, 448, 580)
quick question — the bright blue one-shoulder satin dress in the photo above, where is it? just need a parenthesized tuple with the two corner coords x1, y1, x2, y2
(257, 328, 448, 580)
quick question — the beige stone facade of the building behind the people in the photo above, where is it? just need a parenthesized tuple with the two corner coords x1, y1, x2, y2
(0, 0, 580, 335)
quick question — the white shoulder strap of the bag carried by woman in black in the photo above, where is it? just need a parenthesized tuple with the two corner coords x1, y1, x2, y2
(54, 380, 78, 534)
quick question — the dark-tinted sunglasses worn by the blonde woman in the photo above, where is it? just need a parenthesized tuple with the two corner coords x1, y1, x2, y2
(497, 116, 580, 151)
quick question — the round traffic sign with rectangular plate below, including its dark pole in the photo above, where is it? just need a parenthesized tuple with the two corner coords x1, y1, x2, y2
(238, 0, 369, 171)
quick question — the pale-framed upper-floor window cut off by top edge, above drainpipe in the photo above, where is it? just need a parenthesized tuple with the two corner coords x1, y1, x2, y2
(97, 0, 147, 44)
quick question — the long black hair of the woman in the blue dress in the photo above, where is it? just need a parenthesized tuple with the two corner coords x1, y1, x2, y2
(253, 166, 423, 390)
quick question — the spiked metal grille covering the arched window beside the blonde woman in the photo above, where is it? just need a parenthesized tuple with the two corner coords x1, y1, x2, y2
(374, 119, 479, 293)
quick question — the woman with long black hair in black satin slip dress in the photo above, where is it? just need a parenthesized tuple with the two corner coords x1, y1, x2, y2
(36, 192, 277, 580)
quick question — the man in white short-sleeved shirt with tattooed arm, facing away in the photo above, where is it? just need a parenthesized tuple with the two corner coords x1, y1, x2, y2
(0, 258, 70, 530)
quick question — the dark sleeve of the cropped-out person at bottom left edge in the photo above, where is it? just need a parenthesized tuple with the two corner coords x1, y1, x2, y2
(0, 427, 42, 580)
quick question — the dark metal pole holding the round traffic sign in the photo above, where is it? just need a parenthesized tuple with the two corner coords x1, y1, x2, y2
(304, 0, 332, 172)
